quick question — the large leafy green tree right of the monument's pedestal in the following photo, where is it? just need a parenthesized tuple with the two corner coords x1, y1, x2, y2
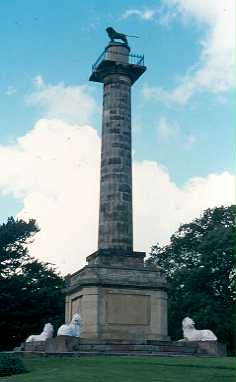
(148, 205, 236, 352)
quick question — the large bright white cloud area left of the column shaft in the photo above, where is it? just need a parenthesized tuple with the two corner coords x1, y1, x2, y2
(0, 119, 100, 272)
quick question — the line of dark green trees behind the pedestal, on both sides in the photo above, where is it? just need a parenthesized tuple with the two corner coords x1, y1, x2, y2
(0, 205, 236, 354)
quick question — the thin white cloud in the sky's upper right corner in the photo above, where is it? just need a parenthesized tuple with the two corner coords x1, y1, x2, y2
(144, 0, 236, 105)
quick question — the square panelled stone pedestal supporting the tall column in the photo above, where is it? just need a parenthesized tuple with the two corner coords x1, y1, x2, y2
(63, 251, 169, 341)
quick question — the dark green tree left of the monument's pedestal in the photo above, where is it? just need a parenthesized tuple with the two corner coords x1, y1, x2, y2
(0, 217, 64, 350)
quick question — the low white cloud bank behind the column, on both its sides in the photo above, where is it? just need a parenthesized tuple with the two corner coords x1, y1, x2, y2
(0, 119, 235, 273)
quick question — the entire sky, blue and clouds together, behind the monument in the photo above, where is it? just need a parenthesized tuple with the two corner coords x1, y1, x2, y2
(0, 0, 236, 274)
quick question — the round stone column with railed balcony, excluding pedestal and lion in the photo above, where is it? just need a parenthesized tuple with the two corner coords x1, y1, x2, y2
(90, 41, 146, 255)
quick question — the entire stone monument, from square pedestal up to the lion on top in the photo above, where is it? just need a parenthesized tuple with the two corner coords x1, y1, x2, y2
(66, 28, 168, 343)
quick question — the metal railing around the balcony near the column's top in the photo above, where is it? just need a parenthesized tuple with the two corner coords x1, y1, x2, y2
(92, 50, 144, 72)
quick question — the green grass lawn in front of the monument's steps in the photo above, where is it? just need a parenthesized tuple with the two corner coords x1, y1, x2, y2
(0, 356, 235, 382)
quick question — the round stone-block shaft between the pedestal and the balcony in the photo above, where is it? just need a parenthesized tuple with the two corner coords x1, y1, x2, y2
(98, 73, 133, 253)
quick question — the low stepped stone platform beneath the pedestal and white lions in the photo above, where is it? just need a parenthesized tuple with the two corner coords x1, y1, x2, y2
(20, 336, 226, 357)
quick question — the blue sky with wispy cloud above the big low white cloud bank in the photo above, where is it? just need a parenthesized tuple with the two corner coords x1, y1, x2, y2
(0, 0, 235, 274)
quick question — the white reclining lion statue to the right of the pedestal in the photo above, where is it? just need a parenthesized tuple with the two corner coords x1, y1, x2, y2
(182, 317, 217, 341)
